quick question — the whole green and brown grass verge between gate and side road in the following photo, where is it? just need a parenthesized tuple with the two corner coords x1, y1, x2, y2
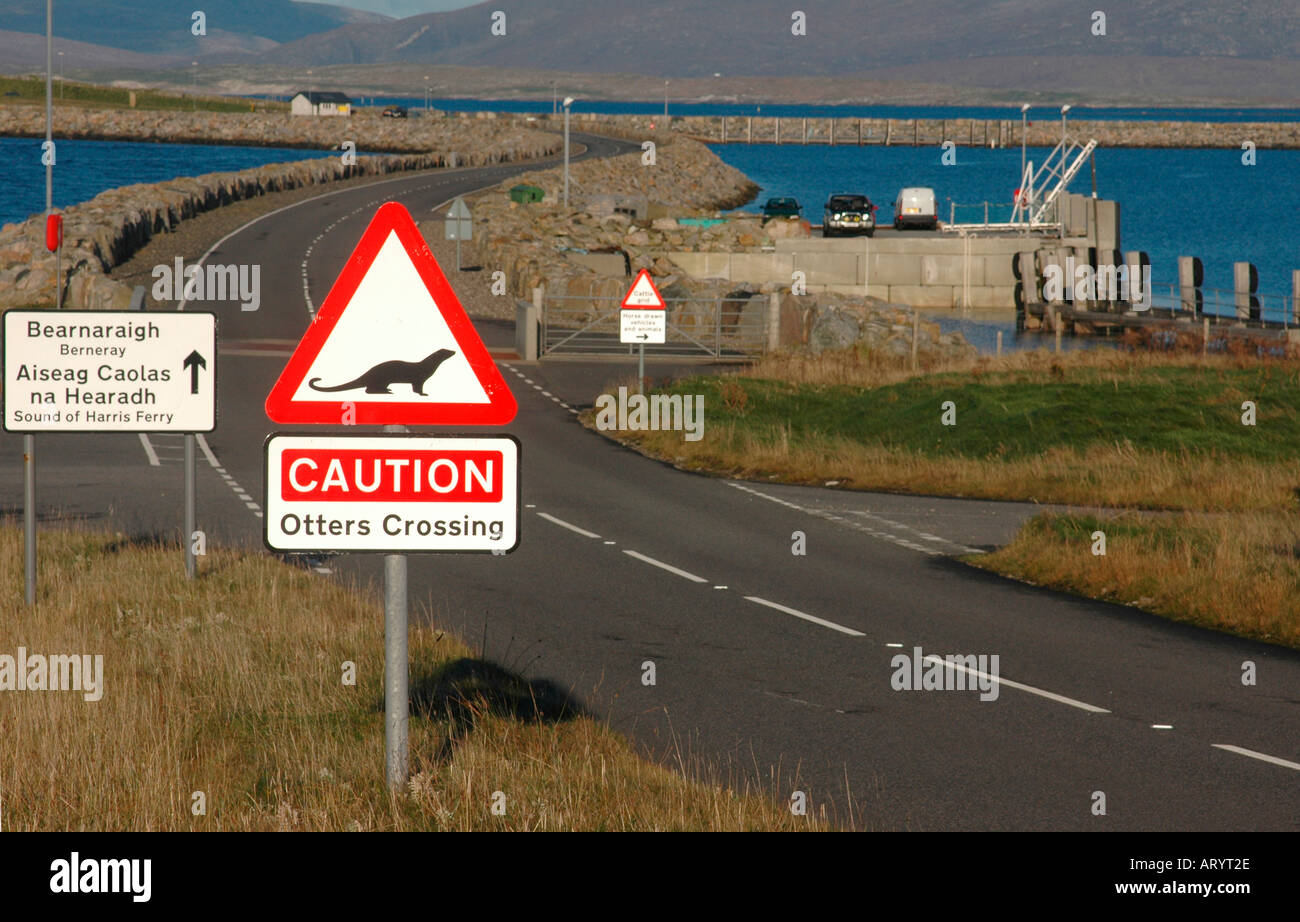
(588, 351, 1300, 511)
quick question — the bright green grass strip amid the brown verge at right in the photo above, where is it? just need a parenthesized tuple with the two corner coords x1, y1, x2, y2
(670, 358, 1300, 462)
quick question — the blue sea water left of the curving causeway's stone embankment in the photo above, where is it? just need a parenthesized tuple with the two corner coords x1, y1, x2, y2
(0, 138, 337, 230)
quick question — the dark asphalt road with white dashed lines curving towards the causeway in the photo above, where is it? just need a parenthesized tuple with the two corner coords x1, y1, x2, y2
(0, 133, 1300, 830)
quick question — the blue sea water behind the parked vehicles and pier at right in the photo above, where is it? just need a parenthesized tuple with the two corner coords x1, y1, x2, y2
(712, 144, 1300, 310)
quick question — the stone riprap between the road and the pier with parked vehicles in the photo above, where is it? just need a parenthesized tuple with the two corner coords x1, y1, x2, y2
(452, 135, 975, 356)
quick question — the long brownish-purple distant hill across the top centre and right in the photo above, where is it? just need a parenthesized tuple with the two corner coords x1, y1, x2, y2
(244, 0, 1300, 75)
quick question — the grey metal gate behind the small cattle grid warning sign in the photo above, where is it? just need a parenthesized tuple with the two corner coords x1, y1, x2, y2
(538, 294, 768, 360)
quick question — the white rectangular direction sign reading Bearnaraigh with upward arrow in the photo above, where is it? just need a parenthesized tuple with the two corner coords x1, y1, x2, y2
(4, 311, 217, 432)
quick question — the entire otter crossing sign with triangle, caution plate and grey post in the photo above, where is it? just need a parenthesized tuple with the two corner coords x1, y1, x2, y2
(263, 199, 520, 793)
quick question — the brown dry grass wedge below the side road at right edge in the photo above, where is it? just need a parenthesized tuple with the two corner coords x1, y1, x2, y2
(967, 512, 1300, 648)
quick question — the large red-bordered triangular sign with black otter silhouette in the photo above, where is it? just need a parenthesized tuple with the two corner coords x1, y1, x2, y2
(267, 202, 517, 425)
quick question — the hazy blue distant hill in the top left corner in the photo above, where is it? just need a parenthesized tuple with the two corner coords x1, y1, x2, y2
(0, 0, 389, 55)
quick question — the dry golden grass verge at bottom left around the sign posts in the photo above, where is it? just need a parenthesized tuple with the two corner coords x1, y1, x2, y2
(0, 528, 826, 830)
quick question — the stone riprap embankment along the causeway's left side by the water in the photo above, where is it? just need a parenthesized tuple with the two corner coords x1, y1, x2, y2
(0, 111, 553, 310)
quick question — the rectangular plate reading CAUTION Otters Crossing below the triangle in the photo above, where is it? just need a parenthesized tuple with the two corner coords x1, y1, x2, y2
(263, 434, 519, 554)
